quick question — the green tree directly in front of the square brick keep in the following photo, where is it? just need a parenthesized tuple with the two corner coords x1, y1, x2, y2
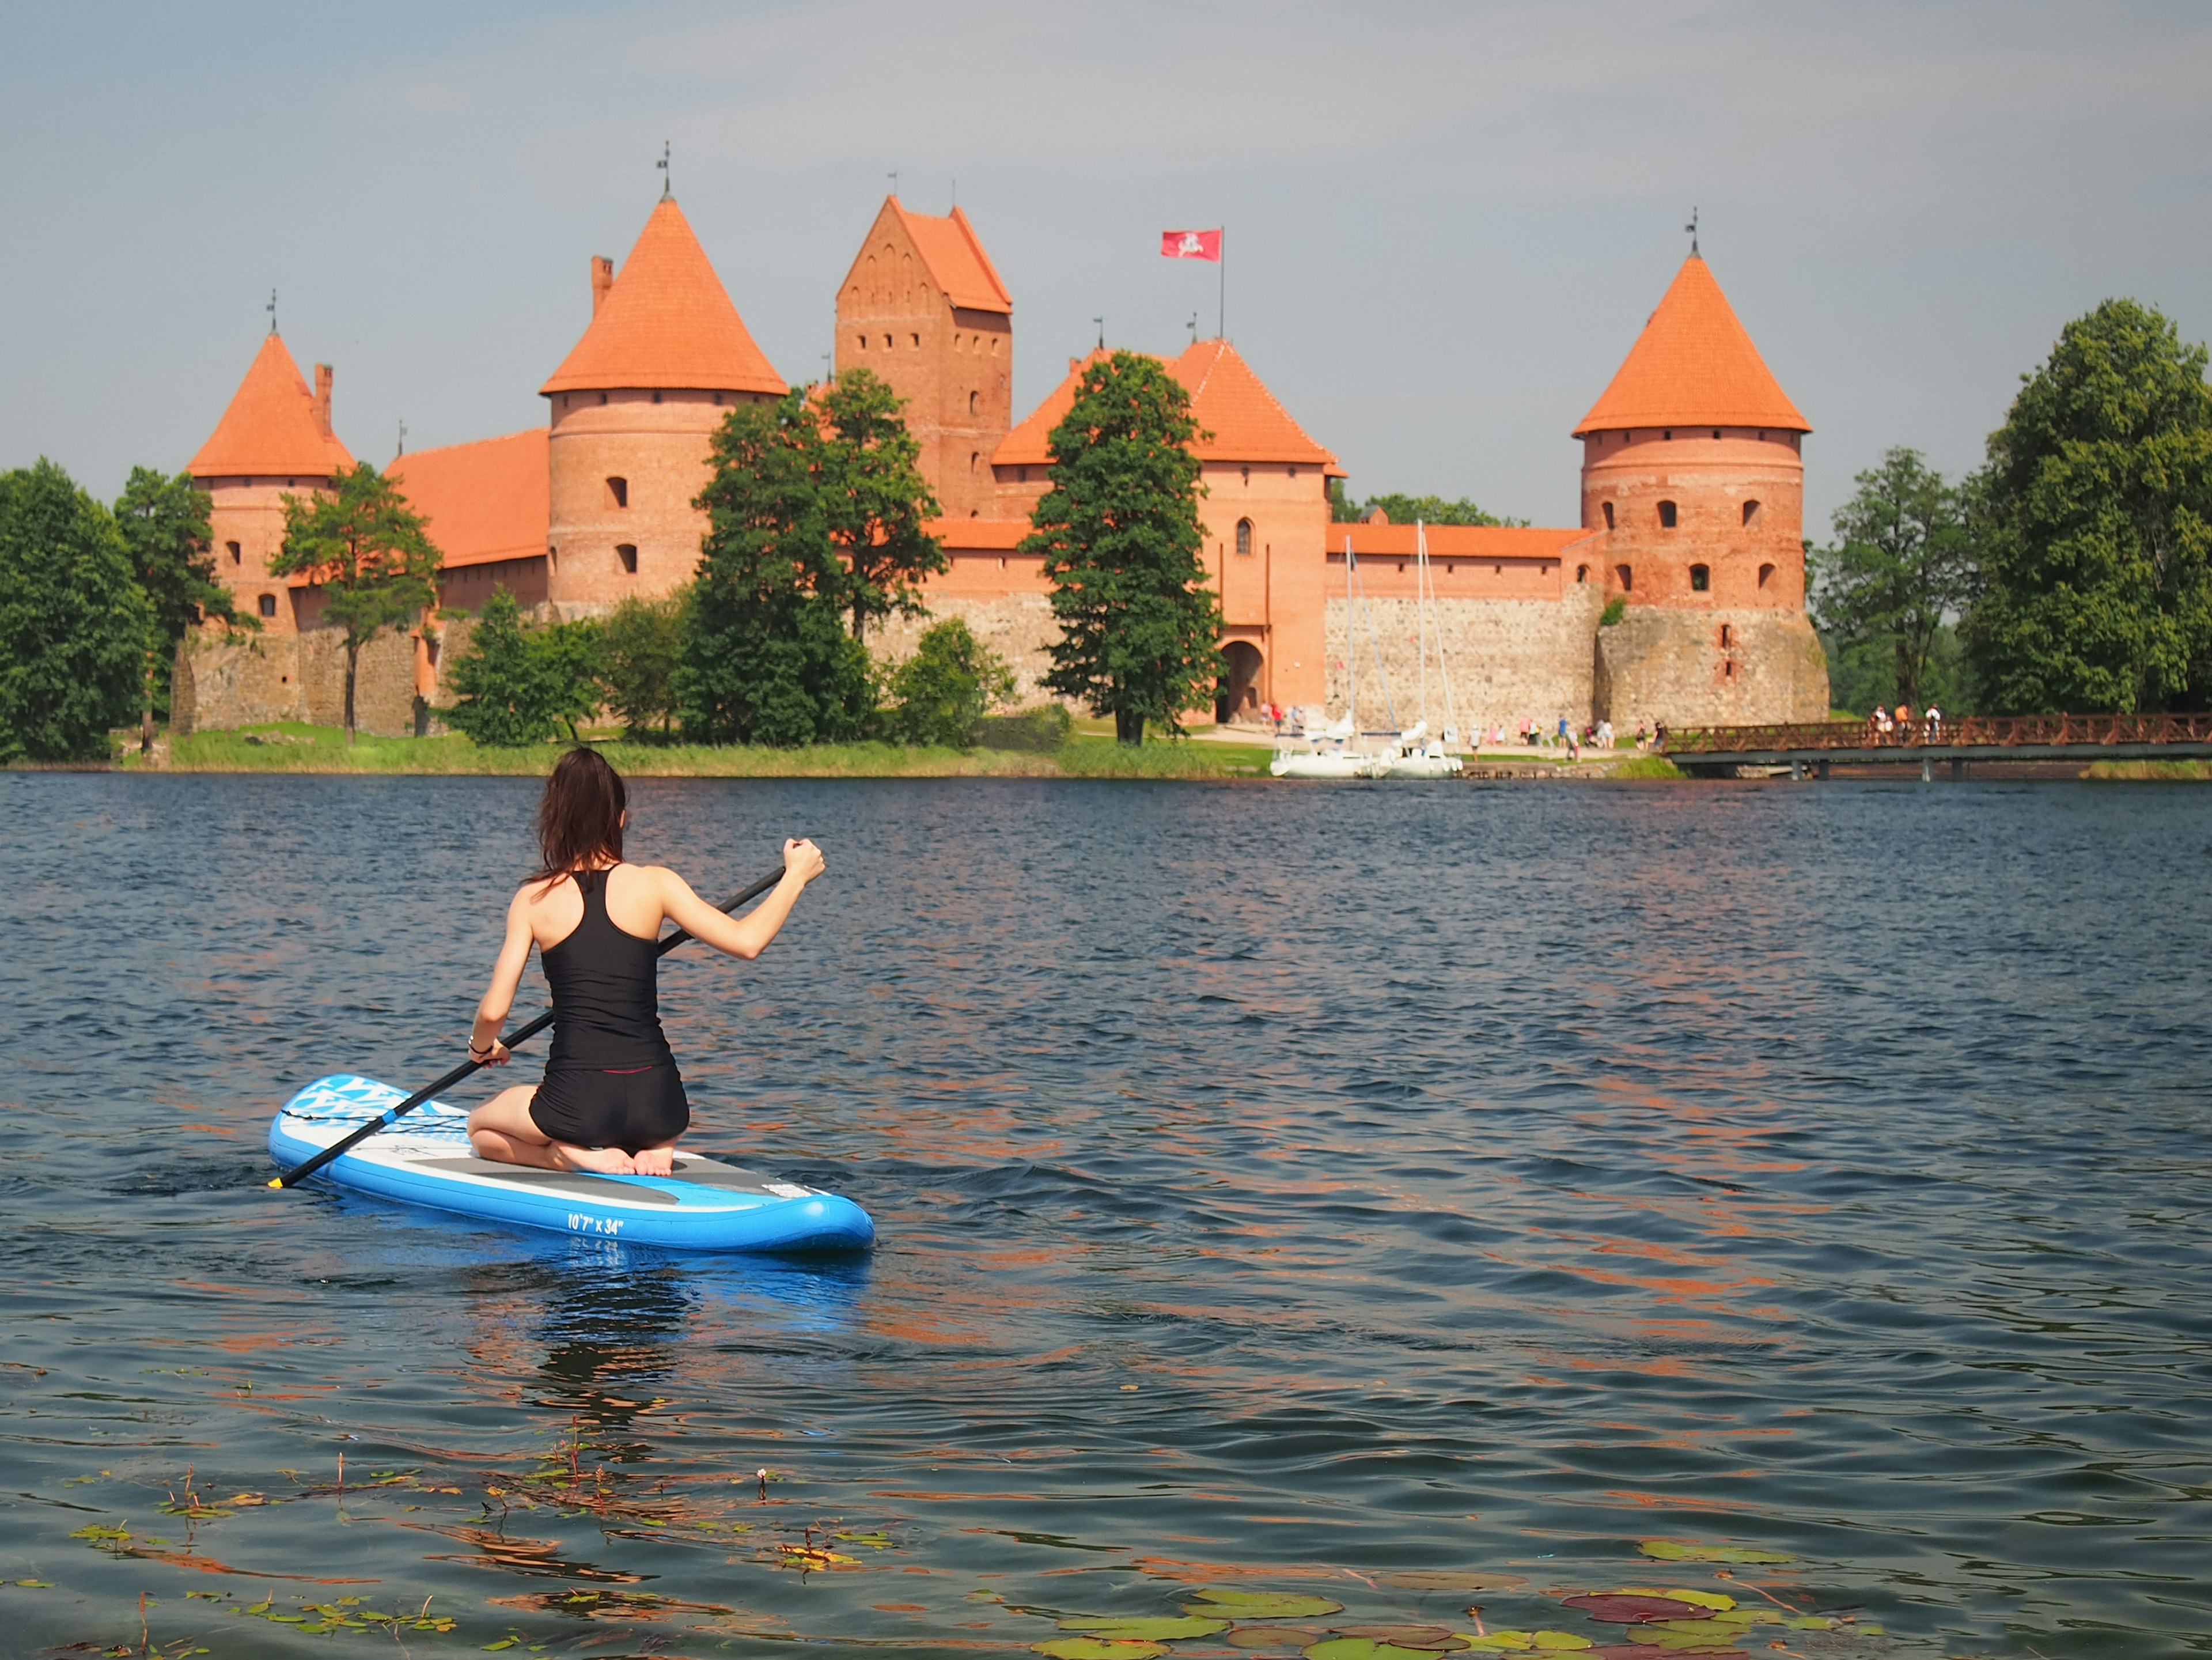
(814, 370, 949, 640)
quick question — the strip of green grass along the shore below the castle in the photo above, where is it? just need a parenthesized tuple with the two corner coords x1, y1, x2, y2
(122, 721, 1267, 779)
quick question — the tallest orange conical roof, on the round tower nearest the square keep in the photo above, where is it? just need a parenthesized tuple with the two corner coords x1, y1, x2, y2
(537, 197, 785, 396)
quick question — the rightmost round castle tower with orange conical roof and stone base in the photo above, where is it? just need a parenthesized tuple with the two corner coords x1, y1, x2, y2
(1575, 248, 1827, 731)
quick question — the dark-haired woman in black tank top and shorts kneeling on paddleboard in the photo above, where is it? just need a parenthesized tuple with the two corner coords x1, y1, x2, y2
(469, 748, 823, 1175)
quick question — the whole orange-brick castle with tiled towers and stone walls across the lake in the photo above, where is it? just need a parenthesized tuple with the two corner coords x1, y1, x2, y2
(179, 197, 1827, 731)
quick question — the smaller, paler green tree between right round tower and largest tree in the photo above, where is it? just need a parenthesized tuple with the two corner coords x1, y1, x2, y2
(1812, 449, 1973, 708)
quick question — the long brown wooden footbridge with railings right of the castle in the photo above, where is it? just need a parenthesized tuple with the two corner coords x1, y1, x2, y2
(1664, 715, 2212, 779)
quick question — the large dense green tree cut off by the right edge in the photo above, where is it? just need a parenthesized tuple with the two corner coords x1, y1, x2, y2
(1964, 299, 2212, 713)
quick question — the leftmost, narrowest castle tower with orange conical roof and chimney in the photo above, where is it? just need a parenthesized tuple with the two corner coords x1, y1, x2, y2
(186, 328, 354, 633)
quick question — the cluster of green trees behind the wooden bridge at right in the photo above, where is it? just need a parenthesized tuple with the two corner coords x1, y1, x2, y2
(1805, 299, 2212, 715)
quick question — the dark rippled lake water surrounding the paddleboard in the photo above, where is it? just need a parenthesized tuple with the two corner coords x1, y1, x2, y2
(0, 774, 2212, 1660)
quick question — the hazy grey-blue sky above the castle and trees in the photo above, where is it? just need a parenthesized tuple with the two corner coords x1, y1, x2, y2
(0, 0, 2212, 538)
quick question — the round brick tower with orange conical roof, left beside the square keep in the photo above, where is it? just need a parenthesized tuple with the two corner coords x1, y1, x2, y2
(540, 195, 787, 618)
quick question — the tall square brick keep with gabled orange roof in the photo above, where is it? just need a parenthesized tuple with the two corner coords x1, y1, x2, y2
(834, 197, 1013, 518)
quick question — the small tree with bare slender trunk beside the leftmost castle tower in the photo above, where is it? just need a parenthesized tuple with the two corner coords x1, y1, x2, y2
(270, 460, 442, 744)
